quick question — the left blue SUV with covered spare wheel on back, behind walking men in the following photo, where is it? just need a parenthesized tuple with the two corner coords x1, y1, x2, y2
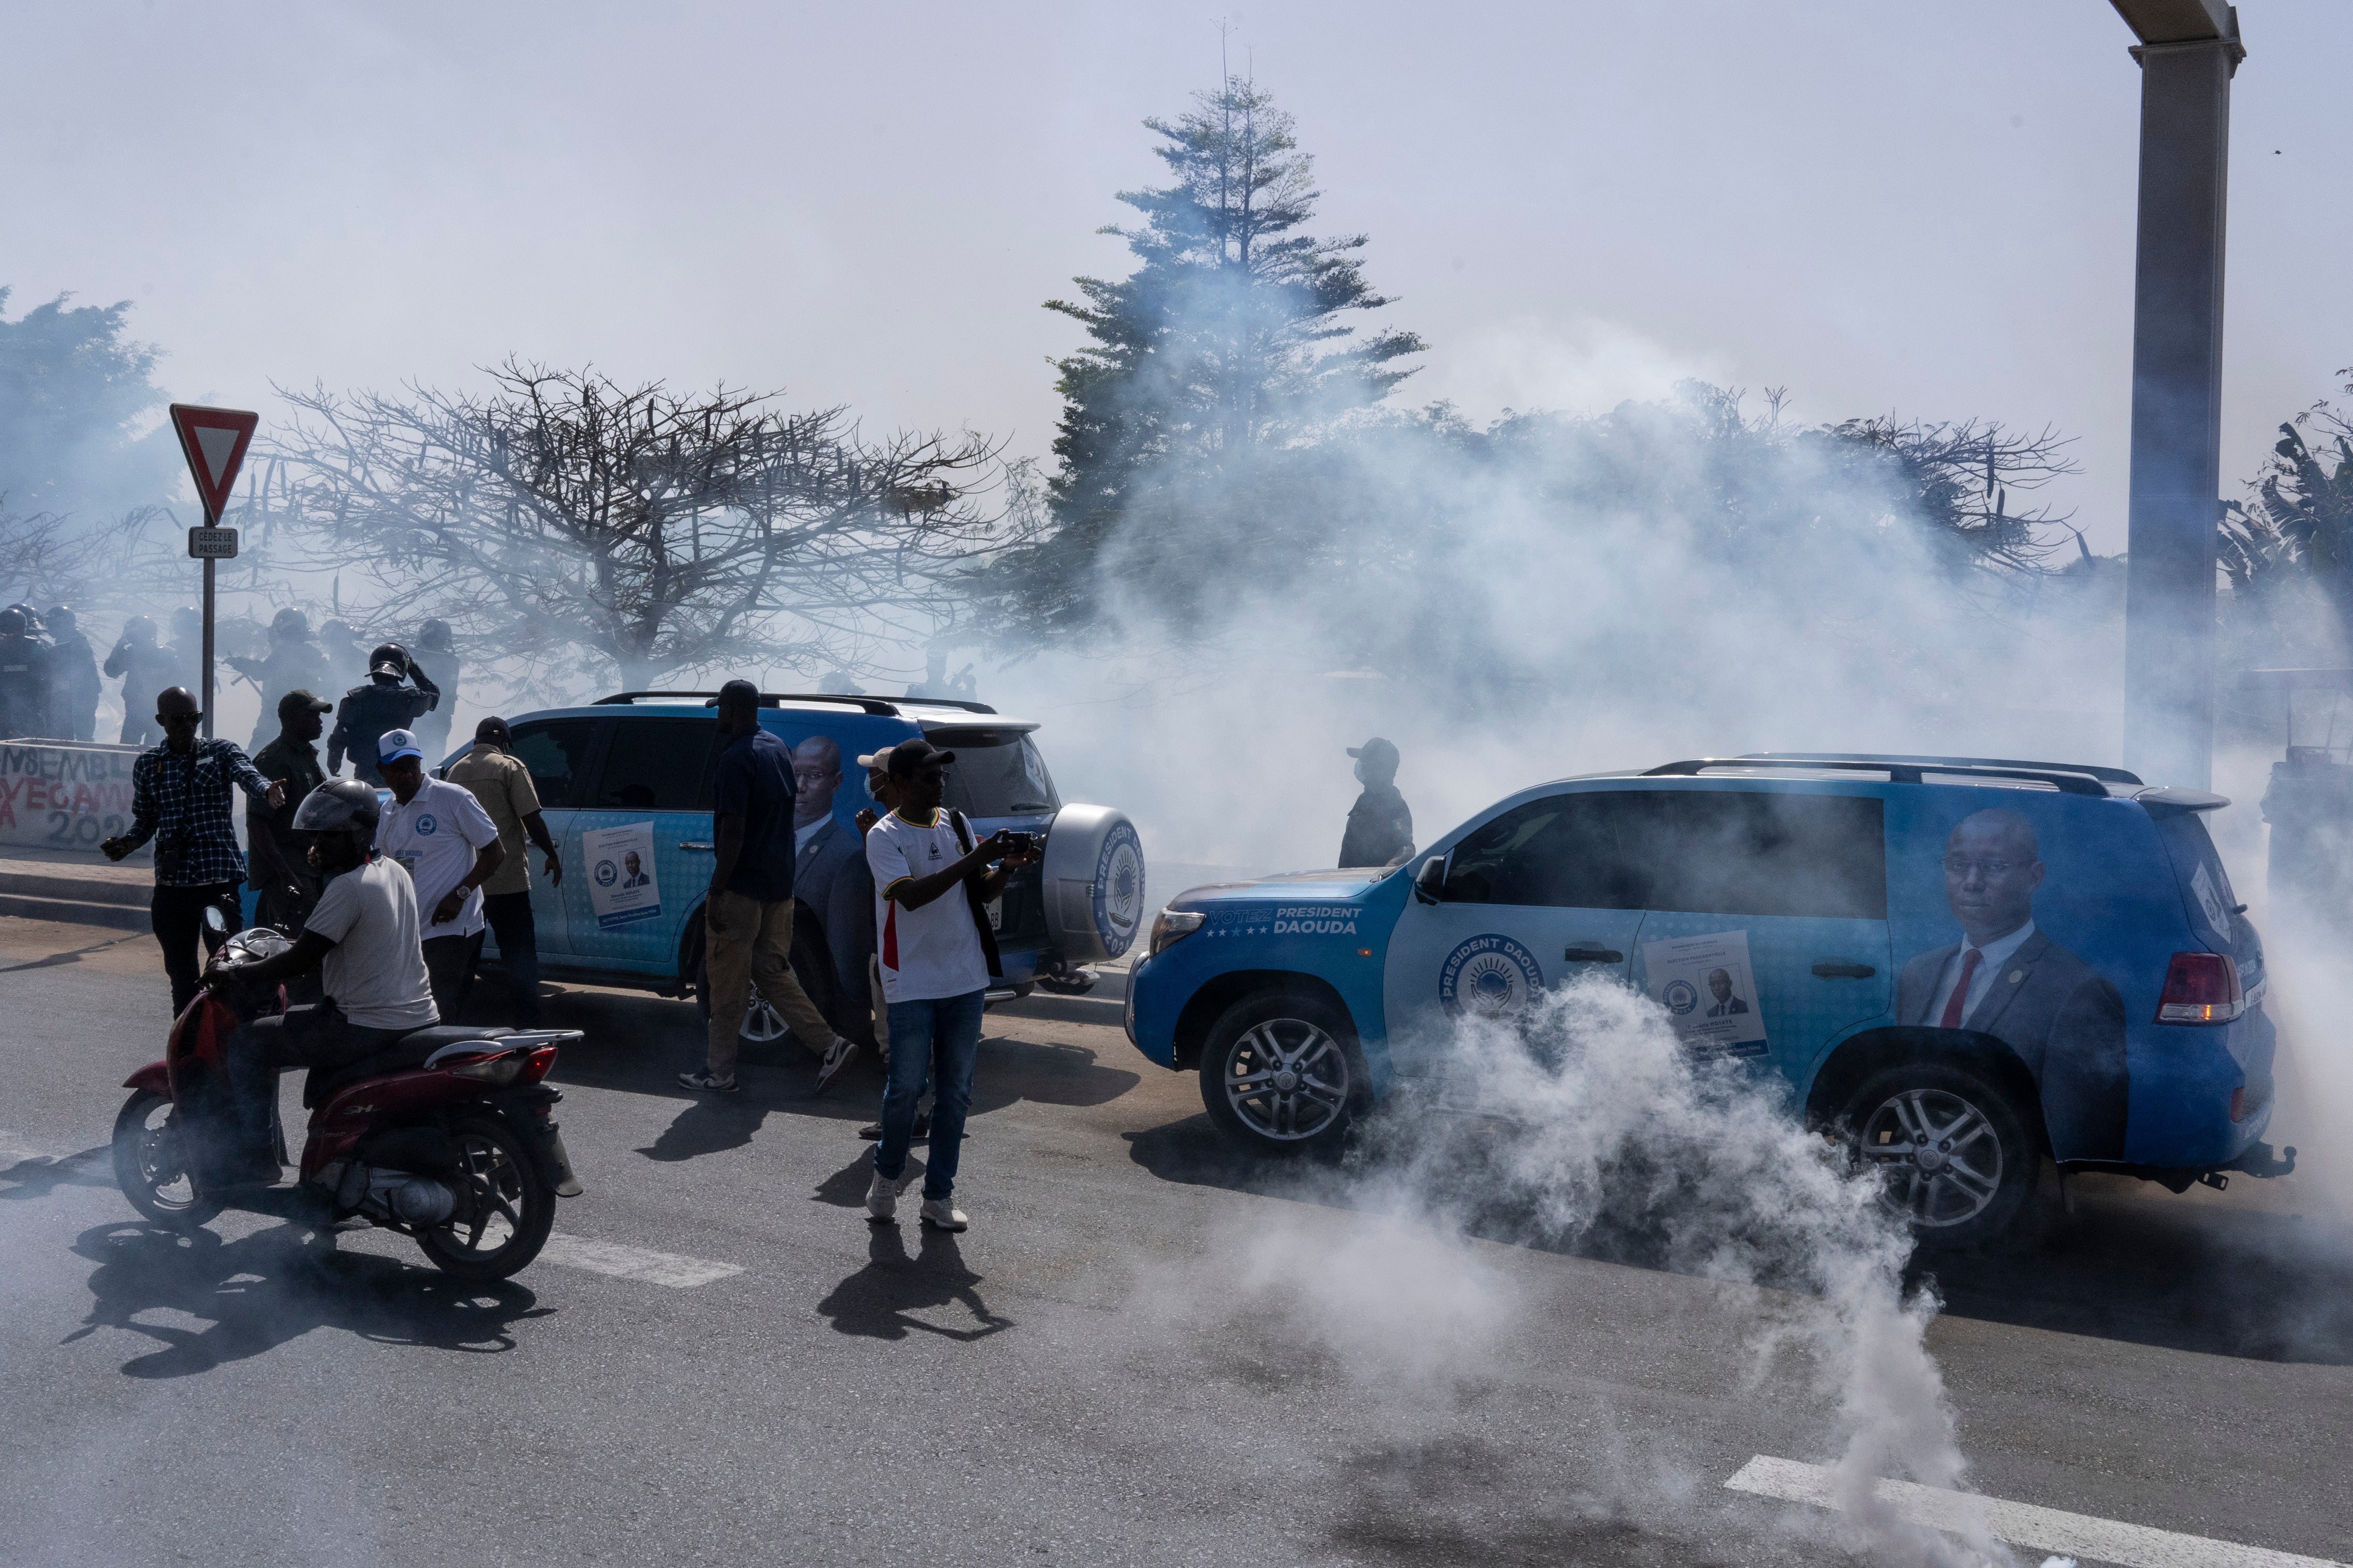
(443, 691, 1143, 1044)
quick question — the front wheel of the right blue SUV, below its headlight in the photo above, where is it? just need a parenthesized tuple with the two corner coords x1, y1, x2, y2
(1200, 992, 1365, 1157)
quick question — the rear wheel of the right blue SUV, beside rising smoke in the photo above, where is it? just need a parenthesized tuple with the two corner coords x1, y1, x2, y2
(1843, 1062, 2040, 1246)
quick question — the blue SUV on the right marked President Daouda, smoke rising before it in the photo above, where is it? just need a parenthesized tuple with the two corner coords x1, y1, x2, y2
(1127, 755, 2294, 1241)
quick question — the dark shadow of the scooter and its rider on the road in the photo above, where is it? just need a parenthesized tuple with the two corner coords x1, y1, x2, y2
(66, 1225, 553, 1378)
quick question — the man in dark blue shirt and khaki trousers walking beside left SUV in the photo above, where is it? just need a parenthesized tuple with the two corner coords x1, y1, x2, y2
(678, 679, 857, 1096)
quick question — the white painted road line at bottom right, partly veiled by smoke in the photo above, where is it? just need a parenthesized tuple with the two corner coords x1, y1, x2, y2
(1725, 1453, 2346, 1568)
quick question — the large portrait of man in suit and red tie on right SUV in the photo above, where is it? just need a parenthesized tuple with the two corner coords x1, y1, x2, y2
(1896, 806, 2127, 1159)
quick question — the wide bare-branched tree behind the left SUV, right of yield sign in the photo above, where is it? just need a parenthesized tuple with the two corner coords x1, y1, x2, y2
(257, 360, 1028, 689)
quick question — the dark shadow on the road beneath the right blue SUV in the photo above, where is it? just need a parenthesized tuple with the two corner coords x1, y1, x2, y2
(1127, 1117, 2353, 1366)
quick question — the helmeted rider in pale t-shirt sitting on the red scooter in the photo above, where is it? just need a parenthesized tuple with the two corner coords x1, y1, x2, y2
(205, 778, 440, 1182)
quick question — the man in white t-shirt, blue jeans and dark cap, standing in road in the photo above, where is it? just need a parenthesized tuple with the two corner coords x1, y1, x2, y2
(866, 741, 1038, 1230)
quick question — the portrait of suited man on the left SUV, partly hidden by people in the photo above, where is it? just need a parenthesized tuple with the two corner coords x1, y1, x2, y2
(793, 736, 875, 1041)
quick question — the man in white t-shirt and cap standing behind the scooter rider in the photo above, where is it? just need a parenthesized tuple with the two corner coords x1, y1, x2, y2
(376, 729, 506, 1023)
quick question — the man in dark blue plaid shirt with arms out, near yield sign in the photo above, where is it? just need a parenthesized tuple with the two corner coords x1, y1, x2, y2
(99, 686, 287, 1018)
